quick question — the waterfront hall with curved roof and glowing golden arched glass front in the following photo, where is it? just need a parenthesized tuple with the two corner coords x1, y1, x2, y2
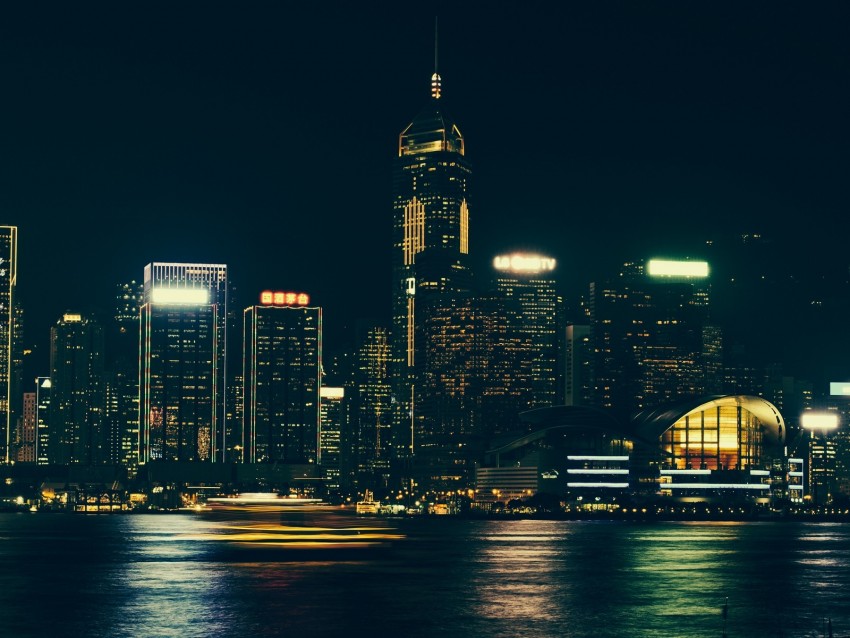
(477, 395, 785, 503)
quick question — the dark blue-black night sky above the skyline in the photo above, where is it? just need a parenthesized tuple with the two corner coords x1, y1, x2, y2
(0, 1, 850, 376)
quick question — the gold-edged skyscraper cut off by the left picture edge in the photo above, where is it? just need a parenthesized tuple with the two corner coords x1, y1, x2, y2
(0, 226, 18, 463)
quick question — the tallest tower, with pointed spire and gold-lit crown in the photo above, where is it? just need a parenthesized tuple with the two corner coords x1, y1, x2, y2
(390, 29, 471, 498)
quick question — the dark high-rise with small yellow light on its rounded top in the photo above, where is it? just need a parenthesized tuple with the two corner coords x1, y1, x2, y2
(48, 313, 107, 465)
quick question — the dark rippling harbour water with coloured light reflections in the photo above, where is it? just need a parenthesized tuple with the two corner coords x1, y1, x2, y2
(0, 514, 850, 638)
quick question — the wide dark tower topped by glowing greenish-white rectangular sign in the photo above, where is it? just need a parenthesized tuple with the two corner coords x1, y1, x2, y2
(590, 259, 720, 418)
